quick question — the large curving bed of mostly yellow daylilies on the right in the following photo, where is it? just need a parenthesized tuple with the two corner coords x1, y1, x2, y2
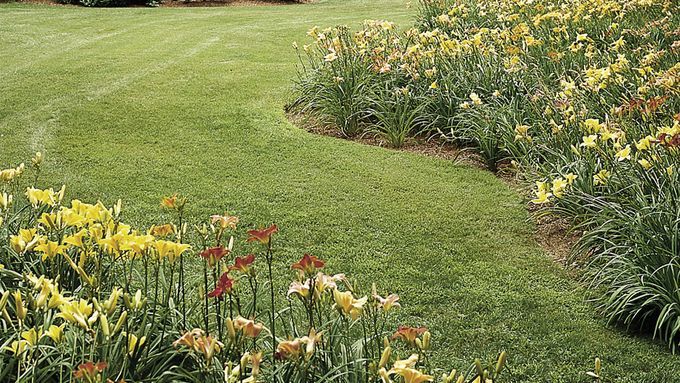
(291, 0, 680, 350)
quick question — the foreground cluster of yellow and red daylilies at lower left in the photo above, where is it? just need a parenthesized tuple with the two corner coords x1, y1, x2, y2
(0, 154, 506, 383)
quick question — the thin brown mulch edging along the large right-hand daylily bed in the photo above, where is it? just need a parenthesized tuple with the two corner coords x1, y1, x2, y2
(288, 113, 580, 266)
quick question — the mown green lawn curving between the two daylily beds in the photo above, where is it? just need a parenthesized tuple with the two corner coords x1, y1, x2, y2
(0, 0, 680, 382)
